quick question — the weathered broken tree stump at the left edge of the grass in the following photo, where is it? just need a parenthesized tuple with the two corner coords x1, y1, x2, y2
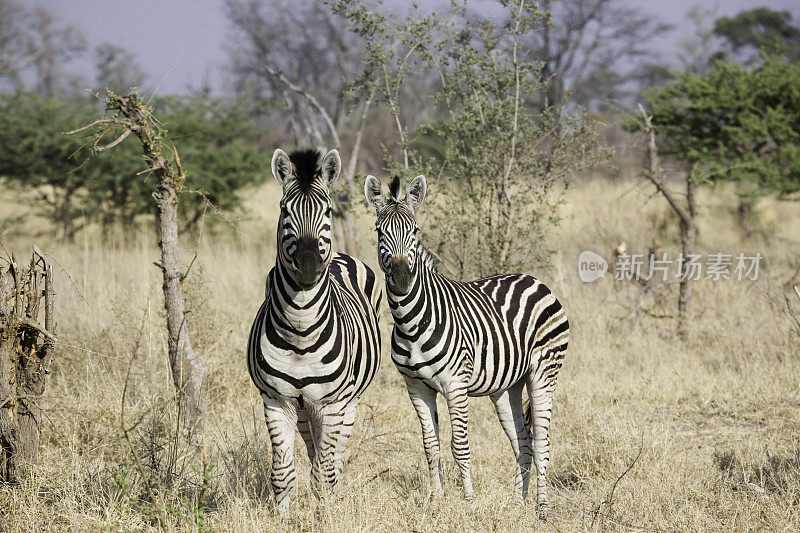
(0, 247, 55, 483)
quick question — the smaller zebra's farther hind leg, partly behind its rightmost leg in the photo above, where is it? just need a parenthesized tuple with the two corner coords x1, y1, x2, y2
(491, 380, 533, 500)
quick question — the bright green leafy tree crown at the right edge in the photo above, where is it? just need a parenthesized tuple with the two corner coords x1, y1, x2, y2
(644, 56, 800, 198)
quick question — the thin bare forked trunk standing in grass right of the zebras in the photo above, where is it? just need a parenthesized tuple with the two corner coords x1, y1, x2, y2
(639, 105, 697, 336)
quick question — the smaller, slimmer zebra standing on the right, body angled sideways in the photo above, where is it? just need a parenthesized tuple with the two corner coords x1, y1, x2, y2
(364, 176, 569, 516)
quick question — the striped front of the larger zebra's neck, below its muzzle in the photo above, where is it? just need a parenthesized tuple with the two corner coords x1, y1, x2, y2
(270, 260, 332, 338)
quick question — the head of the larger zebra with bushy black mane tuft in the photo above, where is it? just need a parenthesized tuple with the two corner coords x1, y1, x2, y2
(272, 149, 342, 290)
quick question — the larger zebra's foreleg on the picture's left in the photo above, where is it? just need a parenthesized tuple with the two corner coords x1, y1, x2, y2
(262, 395, 297, 513)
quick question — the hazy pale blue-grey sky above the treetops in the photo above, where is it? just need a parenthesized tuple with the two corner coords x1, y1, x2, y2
(29, 0, 797, 93)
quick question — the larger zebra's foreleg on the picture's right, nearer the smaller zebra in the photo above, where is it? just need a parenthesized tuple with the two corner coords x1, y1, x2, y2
(311, 404, 356, 496)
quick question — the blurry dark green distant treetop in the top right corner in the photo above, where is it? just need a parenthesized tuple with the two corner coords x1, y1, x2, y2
(714, 7, 800, 63)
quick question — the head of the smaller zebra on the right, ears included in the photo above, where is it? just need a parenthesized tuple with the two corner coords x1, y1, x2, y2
(364, 176, 428, 295)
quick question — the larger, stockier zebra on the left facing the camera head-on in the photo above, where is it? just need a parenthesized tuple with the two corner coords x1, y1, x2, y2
(247, 150, 381, 512)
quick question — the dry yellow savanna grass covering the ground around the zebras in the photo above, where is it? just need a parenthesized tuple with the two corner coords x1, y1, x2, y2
(0, 174, 800, 532)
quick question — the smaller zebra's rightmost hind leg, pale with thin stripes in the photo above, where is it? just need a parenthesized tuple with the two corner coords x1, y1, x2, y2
(528, 377, 556, 520)
